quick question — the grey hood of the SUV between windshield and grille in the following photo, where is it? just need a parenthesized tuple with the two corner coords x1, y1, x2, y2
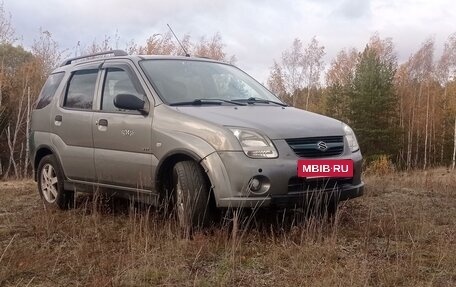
(176, 105, 344, 139)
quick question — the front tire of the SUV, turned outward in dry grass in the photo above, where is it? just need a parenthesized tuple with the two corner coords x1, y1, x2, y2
(173, 161, 210, 235)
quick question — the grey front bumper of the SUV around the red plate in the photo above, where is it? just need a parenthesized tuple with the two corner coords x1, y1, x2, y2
(201, 140, 364, 207)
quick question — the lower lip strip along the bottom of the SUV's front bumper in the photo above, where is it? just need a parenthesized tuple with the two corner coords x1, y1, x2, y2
(216, 182, 364, 208)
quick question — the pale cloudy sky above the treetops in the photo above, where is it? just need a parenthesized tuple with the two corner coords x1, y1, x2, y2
(3, 0, 456, 82)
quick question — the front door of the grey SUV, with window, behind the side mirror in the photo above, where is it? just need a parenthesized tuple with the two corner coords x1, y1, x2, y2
(93, 62, 156, 190)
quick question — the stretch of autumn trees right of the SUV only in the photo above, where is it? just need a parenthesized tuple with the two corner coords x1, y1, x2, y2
(268, 33, 456, 169)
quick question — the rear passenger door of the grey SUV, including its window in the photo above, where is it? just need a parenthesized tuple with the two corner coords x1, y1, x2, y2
(50, 64, 99, 182)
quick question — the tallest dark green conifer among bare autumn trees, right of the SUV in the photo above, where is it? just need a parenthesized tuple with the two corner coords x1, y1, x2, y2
(349, 46, 399, 160)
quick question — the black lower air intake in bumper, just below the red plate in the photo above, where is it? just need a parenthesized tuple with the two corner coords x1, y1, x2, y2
(288, 177, 353, 192)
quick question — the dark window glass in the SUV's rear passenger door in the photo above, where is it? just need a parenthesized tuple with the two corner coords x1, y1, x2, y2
(63, 69, 98, 110)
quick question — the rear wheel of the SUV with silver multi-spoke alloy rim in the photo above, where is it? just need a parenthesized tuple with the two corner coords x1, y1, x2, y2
(37, 155, 74, 210)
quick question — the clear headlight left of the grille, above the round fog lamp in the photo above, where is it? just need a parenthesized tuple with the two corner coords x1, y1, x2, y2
(229, 127, 279, 158)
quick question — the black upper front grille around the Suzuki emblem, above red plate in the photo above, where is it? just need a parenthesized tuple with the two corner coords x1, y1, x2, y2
(285, 136, 344, 157)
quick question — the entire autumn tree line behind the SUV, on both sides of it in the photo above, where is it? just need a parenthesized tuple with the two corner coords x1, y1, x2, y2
(0, 4, 456, 178)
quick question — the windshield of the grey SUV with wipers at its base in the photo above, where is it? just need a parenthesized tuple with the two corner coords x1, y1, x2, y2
(140, 59, 280, 105)
